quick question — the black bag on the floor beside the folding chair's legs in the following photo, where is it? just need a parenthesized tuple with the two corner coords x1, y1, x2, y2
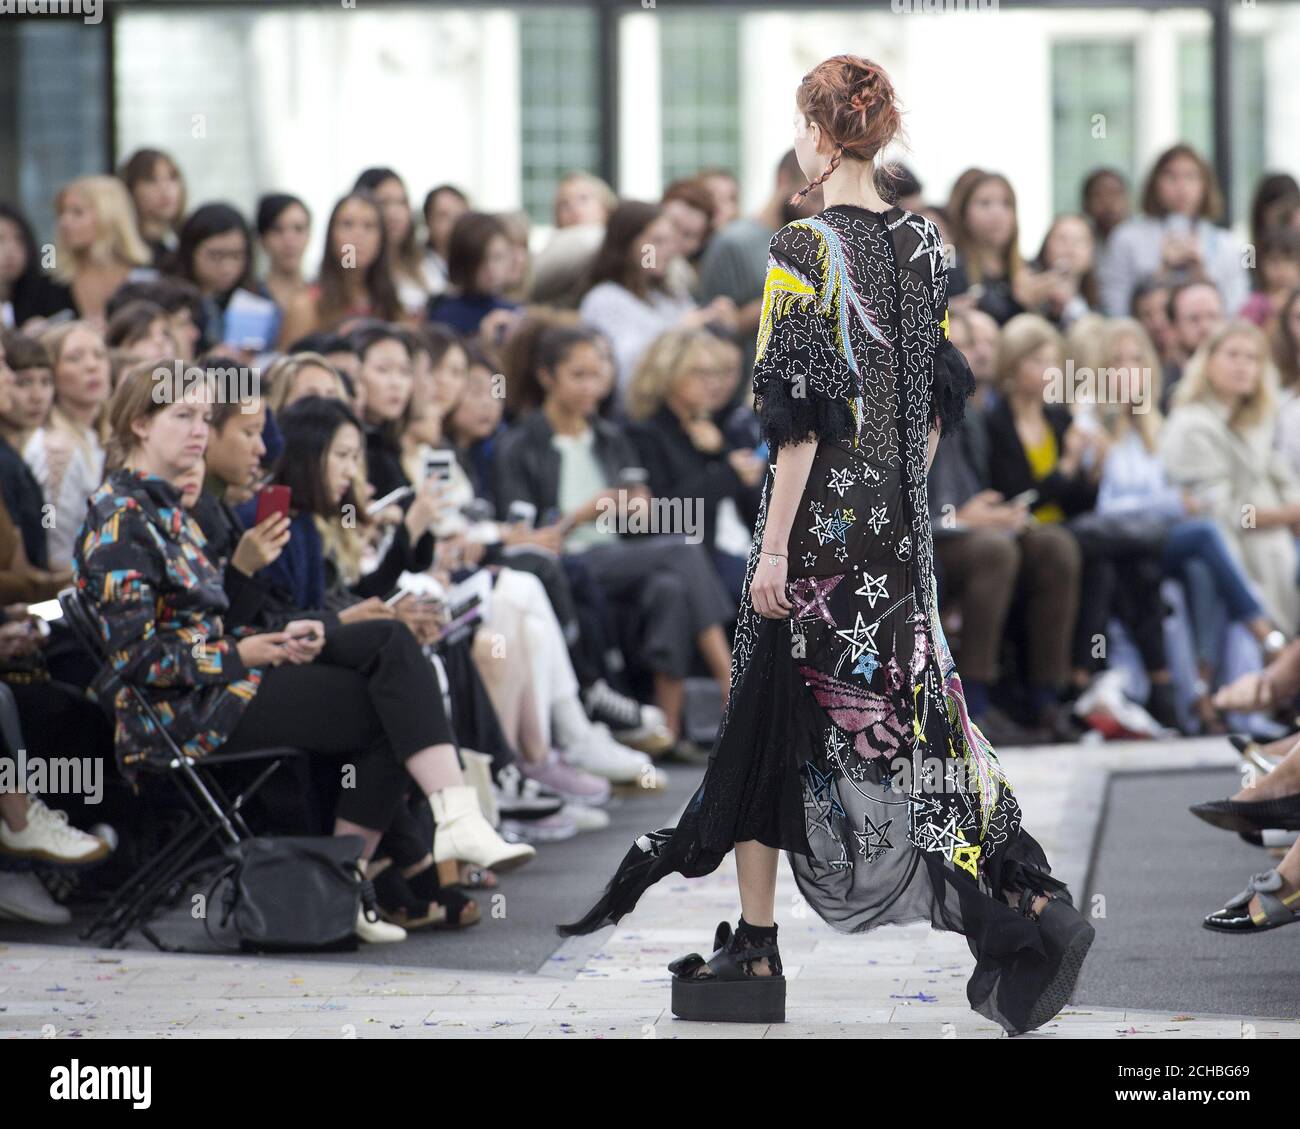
(208, 835, 364, 952)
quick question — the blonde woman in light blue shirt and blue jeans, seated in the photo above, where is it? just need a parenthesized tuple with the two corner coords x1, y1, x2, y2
(1097, 317, 1284, 731)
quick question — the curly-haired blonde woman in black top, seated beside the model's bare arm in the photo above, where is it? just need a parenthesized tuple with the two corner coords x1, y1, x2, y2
(627, 329, 767, 601)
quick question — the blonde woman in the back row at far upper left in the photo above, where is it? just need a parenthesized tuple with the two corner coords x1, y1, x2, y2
(53, 176, 157, 319)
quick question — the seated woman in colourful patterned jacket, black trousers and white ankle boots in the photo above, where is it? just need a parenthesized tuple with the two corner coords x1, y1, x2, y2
(73, 363, 534, 940)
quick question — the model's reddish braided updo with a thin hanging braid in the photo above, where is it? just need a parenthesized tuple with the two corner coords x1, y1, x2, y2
(790, 55, 902, 204)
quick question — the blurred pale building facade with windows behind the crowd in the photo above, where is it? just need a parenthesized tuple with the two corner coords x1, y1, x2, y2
(0, 0, 1300, 254)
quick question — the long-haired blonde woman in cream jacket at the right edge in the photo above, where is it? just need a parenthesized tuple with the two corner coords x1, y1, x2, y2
(1161, 320, 1300, 635)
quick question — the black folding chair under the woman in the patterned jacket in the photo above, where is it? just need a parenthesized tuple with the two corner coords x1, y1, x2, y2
(59, 588, 306, 952)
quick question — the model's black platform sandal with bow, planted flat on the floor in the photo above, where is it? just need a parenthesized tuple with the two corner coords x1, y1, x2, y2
(668, 917, 785, 1024)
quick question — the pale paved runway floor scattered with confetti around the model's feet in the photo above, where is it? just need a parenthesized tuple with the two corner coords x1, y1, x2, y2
(0, 740, 1300, 1039)
